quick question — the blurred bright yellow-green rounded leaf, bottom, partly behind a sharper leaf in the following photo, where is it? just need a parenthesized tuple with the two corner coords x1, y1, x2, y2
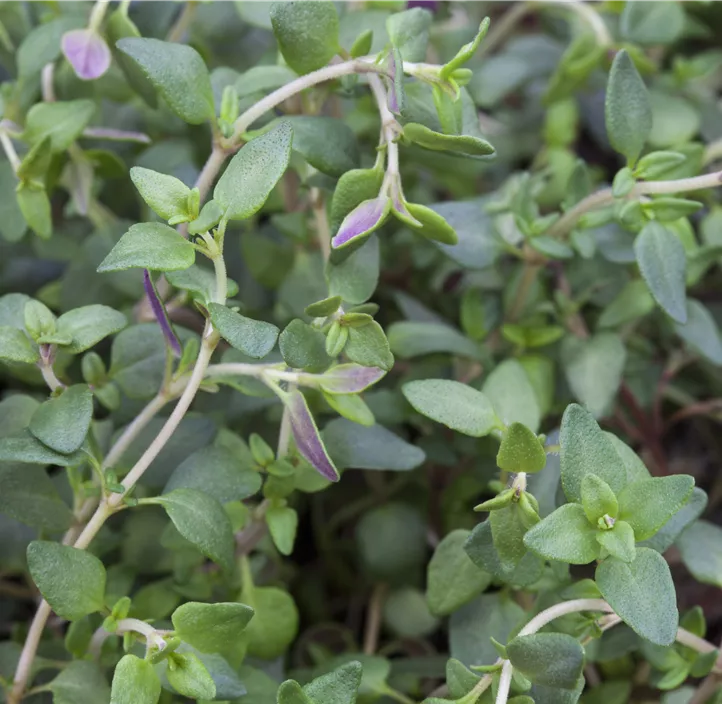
(240, 587, 298, 660)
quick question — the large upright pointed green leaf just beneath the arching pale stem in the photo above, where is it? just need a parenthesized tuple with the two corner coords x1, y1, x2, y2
(213, 121, 293, 220)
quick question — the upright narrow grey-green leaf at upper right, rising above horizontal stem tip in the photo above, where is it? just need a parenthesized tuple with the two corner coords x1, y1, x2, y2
(604, 49, 652, 165)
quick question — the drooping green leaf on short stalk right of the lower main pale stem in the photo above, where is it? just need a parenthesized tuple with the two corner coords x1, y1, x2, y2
(151, 489, 234, 571)
